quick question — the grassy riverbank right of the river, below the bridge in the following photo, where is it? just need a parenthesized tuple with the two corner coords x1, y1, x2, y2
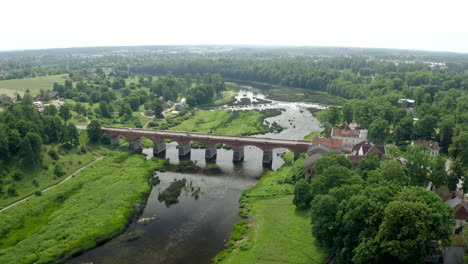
(213, 153, 327, 264)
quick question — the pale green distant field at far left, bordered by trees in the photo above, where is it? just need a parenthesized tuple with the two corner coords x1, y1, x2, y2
(0, 74, 66, 96)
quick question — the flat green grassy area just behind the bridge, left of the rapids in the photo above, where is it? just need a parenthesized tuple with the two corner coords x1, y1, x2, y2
(170, 110, 276, 135)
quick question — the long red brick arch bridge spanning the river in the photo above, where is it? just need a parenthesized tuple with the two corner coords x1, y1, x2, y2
(102, 127, 312, 164)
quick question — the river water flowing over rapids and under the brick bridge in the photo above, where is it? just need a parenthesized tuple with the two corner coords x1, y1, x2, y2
(68, 87, 321, 264)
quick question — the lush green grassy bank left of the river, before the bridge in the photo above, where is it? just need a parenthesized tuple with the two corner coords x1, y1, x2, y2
(0, 153, 163, 264)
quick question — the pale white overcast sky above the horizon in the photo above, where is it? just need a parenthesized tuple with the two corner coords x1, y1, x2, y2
(0, 0, 468, 53)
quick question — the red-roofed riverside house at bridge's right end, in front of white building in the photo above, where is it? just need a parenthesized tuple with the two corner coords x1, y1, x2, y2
(304, 137, 343, 180)
